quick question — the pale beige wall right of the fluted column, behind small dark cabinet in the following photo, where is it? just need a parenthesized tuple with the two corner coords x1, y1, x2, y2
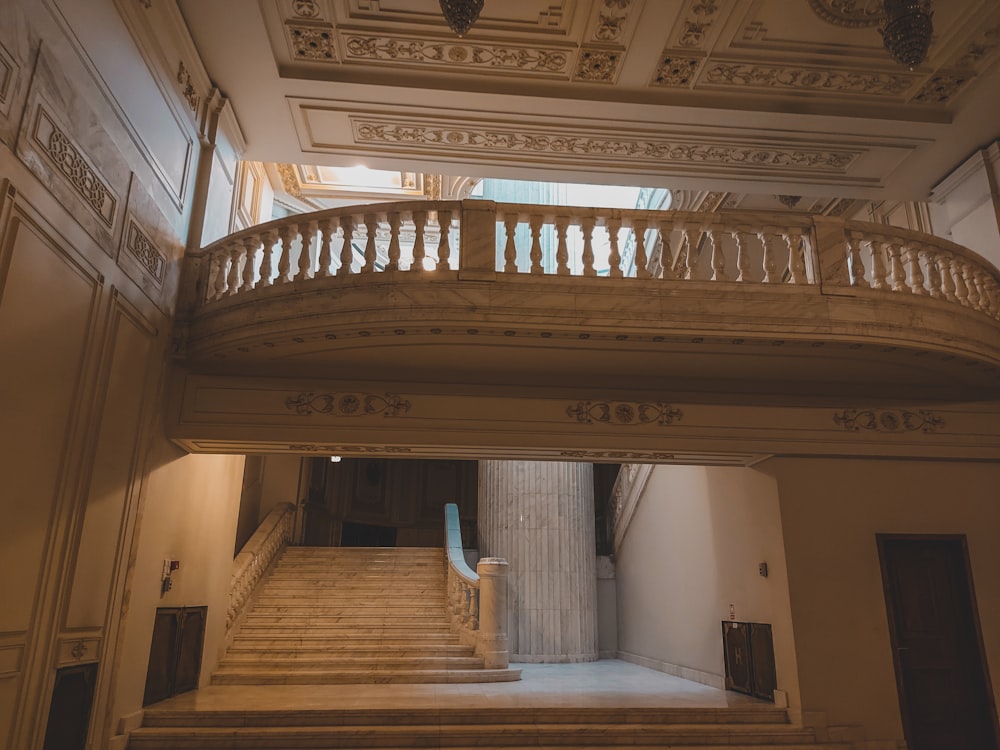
(616, 466, 797, 703)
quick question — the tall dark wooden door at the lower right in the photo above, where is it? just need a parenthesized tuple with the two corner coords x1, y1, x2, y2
(878, 535, 997, 750)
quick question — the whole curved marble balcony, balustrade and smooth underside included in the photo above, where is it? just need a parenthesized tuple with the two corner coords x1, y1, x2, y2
(179, 201, 1000, 400)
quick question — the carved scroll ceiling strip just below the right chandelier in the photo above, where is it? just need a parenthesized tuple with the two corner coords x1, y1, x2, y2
(702, 63, 913, 96)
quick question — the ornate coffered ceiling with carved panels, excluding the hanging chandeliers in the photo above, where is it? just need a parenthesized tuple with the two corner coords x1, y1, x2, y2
(179, 0, 1000, 198)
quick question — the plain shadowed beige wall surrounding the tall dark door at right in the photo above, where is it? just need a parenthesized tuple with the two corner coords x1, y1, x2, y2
(762, 459, 1000, 741)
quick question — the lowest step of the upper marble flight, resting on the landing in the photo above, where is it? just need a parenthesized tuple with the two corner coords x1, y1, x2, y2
(212, 668, 521, 685)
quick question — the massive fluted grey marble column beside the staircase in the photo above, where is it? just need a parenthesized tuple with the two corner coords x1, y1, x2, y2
(479, 461, 597, 662)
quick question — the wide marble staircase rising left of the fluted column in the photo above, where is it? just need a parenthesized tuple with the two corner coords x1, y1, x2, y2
(212, 547, 520, 685)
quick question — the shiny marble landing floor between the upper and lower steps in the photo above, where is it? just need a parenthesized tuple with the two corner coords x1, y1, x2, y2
(150, 660, 774, 711)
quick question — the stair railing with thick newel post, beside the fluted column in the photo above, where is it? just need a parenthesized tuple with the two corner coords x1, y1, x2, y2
(444, 503, 510, 669)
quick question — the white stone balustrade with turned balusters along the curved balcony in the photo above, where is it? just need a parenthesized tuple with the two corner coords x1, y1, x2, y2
(188, 200, 1000, 319)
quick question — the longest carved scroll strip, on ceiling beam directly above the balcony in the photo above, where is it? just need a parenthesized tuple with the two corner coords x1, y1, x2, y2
(352, 118, 861, 172)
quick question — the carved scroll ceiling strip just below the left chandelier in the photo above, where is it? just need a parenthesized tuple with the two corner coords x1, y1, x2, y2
(344, 35, 569, 75)
